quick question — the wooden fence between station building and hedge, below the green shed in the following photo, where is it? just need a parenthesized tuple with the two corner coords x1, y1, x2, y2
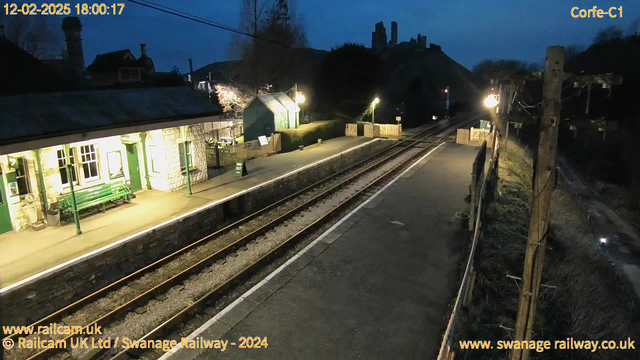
(207, 134, 282, 168)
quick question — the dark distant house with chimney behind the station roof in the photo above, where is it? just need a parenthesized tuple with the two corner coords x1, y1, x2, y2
(87, 44, 155, 86)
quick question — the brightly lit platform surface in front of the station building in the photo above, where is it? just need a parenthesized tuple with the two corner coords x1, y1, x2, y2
(0, 137, 372, 291)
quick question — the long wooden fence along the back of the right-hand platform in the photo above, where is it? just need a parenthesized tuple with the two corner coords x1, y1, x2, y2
(438, 131, 500, 360)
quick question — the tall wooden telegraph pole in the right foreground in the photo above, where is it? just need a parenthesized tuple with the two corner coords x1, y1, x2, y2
(511, 46, 564, 360)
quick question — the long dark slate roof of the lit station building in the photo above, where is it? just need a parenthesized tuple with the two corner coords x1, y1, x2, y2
(0, 87, 221, 145)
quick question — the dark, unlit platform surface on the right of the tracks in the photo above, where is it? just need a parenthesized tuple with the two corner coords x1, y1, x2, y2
(166, 143, 478, 360)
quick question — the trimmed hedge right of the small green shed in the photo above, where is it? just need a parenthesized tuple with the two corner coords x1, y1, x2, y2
(279, 120, 345, 152)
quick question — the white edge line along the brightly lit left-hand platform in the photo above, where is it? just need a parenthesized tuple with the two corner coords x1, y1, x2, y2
(0, 138, 382, 294)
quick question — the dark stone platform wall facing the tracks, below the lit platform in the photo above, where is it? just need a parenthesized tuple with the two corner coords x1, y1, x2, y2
(0, 141, 392, 325)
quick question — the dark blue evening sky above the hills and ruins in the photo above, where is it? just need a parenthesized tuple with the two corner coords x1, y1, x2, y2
(74, 0, 640, 72)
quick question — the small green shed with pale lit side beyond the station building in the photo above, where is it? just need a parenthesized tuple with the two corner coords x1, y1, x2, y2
(242, 93, 299, 141)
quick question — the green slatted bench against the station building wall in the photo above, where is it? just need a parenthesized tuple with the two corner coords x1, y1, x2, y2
(58, 180, 133, 218)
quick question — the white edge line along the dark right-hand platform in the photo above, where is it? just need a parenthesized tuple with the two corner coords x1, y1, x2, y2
(159, 142, 446, 360)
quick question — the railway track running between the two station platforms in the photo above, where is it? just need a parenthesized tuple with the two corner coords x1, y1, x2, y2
(5, 115, 474, 359)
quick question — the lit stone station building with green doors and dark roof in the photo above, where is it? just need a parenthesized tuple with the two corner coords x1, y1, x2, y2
(0, 87, 221, 233)
